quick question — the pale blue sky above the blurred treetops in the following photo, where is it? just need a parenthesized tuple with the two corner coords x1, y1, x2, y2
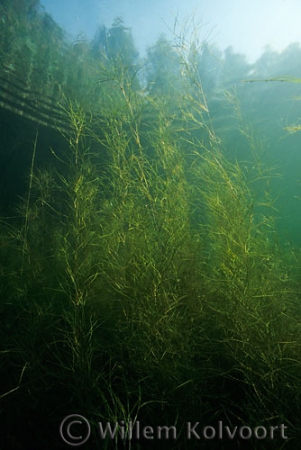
(41, 0, 301, 62)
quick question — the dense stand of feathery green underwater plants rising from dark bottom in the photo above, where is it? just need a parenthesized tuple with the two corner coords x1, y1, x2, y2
(0, 29, 301, 449)
